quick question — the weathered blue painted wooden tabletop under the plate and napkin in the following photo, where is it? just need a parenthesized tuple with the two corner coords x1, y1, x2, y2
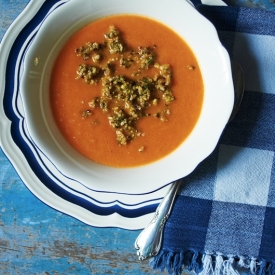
(0, 0, 275, 275)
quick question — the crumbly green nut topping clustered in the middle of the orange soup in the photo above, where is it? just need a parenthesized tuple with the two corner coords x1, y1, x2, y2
(76, 26, 175, 147)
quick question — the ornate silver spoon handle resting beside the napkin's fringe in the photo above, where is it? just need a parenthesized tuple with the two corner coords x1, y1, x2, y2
(135, 180, 181, 260)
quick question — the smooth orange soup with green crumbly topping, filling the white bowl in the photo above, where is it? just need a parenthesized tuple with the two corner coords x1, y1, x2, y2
(50, 15, 204, 167)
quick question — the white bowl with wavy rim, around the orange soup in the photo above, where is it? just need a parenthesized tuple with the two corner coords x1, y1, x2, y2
(21, 0, 234, 194)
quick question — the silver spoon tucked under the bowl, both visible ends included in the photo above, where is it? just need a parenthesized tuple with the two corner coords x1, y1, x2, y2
(135, 61, 244, 260)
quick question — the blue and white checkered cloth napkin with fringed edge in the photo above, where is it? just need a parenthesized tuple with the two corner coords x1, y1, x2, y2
(151, 2, 275, 275)
